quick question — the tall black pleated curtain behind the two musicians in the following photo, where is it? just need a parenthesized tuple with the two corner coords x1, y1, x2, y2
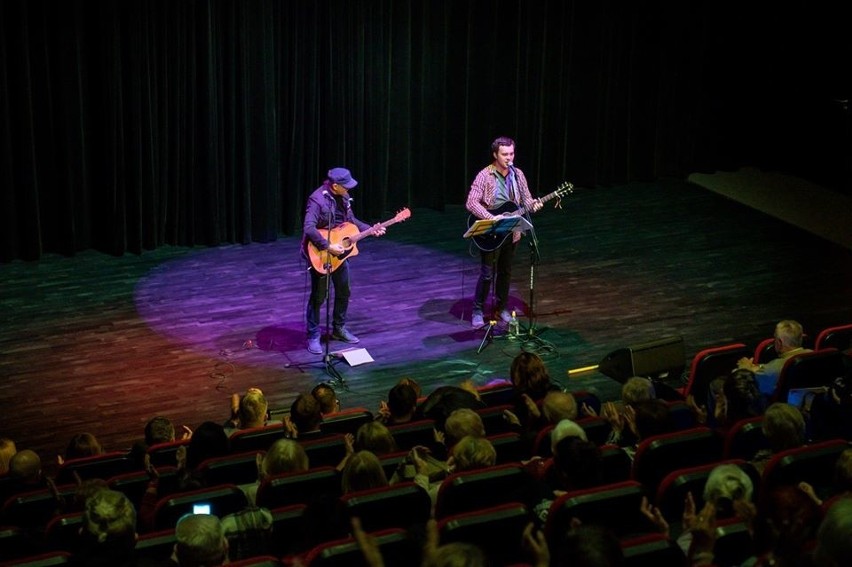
(0, 0, 850, 261)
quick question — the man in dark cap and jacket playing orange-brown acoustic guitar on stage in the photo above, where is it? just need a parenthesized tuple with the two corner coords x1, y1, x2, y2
(302, 167, 385, 354)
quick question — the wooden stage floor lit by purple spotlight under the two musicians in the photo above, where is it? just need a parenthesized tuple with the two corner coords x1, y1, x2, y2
(0, 180, 852, 471)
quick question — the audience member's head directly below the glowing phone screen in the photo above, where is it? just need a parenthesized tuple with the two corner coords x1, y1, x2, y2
(172, 514, 228, 567)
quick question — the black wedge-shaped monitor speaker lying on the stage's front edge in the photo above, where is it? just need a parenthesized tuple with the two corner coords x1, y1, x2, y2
(598, 337, 686, 384)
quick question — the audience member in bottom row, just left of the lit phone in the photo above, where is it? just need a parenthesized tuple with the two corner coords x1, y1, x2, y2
(71, 488, 136, 567)
